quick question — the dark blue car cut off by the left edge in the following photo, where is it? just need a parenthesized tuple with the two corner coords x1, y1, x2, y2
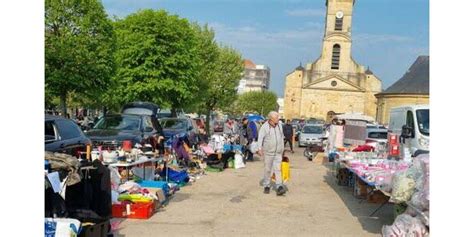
(44, 115, 91, 156)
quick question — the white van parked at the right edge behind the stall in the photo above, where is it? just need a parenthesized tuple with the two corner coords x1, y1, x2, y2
(388, 105, 430, 159)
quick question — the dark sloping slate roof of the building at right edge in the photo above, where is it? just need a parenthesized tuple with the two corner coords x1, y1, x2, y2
(381, 56, 430, 94)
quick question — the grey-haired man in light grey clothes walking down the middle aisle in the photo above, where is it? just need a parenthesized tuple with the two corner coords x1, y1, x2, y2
(258, 111, 286, 196)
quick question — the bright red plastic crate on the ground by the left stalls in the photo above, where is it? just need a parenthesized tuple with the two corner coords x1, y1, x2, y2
(112, 202, 155, 219)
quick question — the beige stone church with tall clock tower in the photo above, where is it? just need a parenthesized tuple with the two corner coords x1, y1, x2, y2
(284, 0, 382, 119)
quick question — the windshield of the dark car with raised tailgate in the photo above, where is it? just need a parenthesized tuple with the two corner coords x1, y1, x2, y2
(94, 115, 140, 131)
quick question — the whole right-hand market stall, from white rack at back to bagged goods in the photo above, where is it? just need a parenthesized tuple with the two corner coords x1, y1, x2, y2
(326, 115, 429, 236)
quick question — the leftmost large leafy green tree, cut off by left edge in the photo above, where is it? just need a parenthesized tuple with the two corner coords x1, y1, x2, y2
(45, 0, 115, 115)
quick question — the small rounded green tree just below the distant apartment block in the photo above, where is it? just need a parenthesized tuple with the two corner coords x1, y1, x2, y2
(237, 91, 278, 116)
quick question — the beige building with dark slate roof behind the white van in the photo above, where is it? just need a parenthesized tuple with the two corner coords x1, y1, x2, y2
(375, 56, 430, 124)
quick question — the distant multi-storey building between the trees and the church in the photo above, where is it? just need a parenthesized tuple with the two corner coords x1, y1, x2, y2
(237, 59, 270, 94)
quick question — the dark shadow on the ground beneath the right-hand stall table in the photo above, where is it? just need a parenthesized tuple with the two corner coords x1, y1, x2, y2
(324, 164, 394, 233)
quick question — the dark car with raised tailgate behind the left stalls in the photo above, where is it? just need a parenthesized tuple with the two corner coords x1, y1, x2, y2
(86, 102, 163, 149)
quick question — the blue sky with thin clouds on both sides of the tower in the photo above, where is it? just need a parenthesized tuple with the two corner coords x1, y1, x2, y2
(102, 0, 429, 97)
